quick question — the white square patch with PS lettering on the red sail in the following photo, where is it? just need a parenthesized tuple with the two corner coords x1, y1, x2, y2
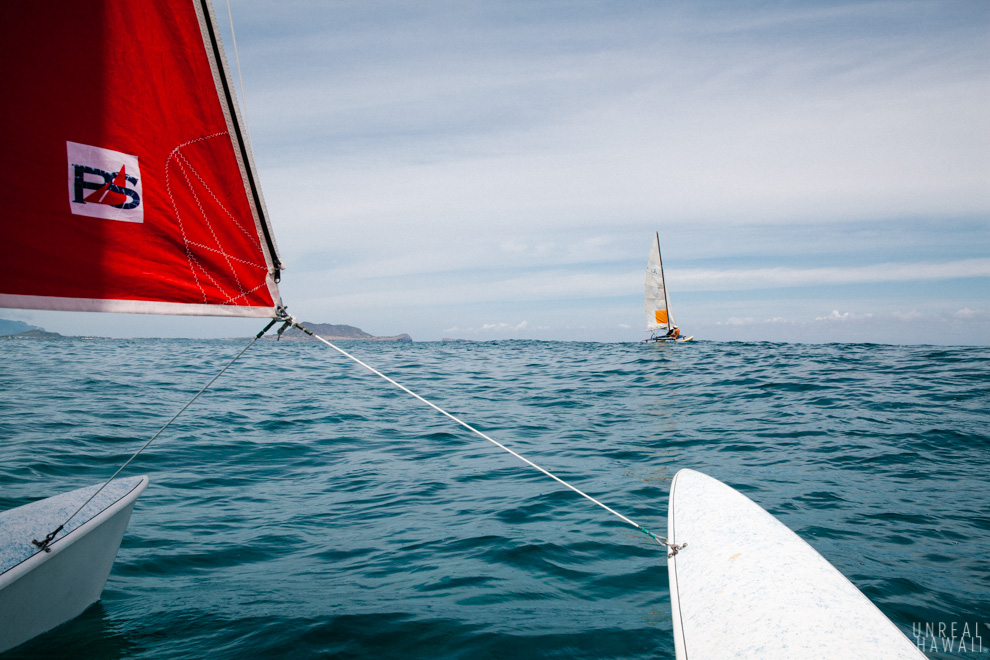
(65, 142, 144, 222)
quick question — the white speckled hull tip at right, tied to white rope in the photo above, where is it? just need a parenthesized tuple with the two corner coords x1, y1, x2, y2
(667, 470, 925, 660)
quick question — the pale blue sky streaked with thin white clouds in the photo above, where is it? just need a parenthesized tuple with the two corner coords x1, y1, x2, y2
(0, 0, 990, 345)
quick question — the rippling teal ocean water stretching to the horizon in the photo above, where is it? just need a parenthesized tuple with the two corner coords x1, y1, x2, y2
(0, 339, 990, 659)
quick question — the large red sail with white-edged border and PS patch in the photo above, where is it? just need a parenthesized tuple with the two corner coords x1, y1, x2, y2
(0, 0, 282, 316)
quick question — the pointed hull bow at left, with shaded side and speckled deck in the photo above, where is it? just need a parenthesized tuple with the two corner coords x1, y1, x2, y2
(0, 477, 148, 653)
